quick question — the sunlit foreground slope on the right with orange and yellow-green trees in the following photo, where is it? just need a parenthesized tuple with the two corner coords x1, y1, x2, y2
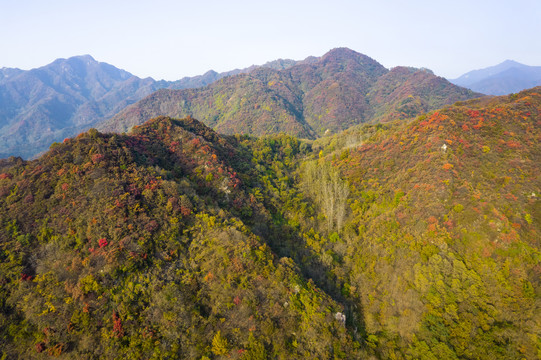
(298, 87, 541, 359)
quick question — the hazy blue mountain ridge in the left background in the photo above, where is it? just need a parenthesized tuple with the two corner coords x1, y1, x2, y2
(0, 55, 304, 158)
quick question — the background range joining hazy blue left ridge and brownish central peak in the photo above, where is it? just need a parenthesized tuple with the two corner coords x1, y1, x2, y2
(0, 48, 480, 158)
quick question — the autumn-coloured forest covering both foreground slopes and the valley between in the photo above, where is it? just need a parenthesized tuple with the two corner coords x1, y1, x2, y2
(0, 86, 541, 360)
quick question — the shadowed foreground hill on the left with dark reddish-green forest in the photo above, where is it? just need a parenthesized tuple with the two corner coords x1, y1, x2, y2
(0, 118, 361, 359)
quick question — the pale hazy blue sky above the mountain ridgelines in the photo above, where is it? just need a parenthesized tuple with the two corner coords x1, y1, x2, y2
(0, 0, 541, 81)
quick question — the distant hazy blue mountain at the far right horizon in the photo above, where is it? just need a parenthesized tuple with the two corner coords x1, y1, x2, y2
(449, 60, 541, 95)
